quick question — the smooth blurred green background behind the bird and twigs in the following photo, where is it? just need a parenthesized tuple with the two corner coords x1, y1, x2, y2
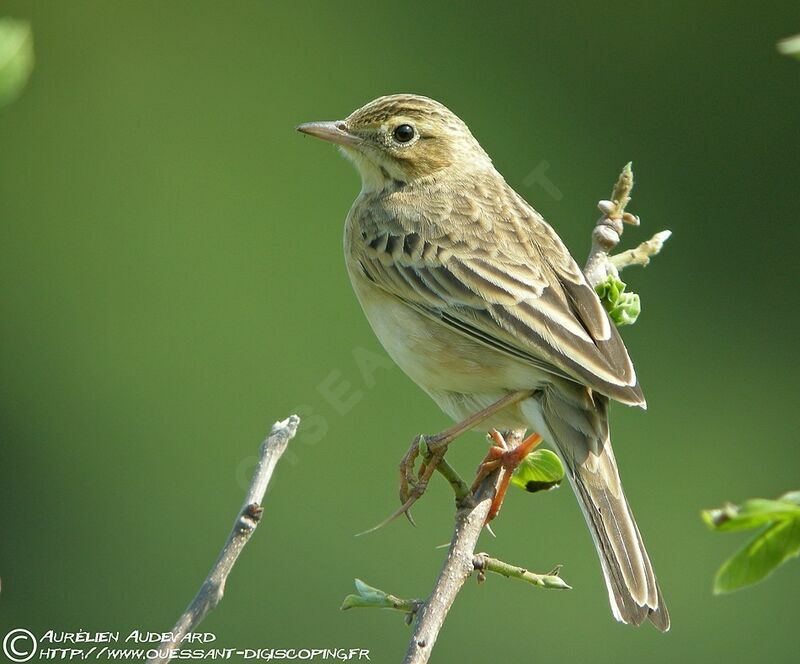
(0, 0, 800, 663)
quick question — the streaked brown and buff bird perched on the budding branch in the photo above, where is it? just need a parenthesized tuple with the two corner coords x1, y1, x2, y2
(297, 94, 670, 631)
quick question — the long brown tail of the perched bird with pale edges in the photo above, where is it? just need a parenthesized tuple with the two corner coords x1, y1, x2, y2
(526, 390, 669, 632)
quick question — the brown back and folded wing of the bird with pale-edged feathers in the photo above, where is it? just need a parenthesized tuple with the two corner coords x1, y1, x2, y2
(354, 176, 644, 405)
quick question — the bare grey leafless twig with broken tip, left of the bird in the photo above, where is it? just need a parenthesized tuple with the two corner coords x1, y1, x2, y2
(148, 415, 300, 664)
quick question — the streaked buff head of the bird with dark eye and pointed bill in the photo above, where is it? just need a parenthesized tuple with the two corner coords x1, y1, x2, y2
(297, 94, 492, 191)
